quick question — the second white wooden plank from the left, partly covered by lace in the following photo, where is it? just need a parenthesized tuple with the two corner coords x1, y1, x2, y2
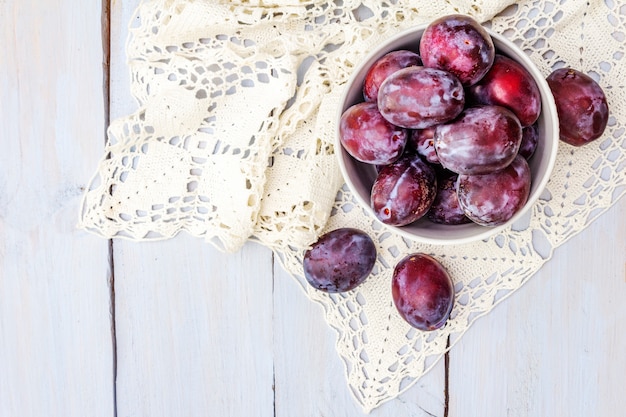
(111, 0, 274, 417)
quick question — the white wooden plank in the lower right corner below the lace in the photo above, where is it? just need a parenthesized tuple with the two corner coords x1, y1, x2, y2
(449, 198, 626, 417)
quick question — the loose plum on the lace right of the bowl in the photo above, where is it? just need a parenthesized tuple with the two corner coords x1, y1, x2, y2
(546, 68, 609, 146)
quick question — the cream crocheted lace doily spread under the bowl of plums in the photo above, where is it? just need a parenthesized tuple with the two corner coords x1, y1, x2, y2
(79, 0, 626, 411)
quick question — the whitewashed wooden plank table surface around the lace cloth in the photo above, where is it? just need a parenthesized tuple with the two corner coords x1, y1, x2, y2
(0, 0, 626, 417)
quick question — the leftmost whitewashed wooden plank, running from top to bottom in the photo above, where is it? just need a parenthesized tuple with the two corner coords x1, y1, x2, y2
(0, 0, 114, 417)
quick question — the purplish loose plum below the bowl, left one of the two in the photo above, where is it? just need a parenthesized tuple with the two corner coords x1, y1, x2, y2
(303, 228, 376, 293)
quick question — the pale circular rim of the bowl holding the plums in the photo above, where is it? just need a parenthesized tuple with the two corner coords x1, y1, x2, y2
(335, 23, 559, 245)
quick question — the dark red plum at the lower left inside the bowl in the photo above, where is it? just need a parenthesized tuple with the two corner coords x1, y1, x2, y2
(371, 154, 437, 226)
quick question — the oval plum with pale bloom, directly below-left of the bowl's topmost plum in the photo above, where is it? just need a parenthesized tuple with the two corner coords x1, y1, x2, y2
(378, 67, 465, 129)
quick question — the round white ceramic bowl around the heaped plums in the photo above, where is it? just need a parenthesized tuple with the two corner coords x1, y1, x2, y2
(336, 25, 559, 245)
